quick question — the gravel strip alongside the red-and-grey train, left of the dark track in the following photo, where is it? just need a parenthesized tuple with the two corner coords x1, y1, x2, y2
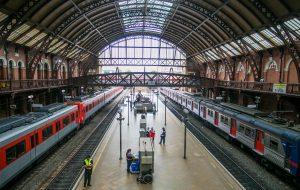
(5, 92, 124, 190)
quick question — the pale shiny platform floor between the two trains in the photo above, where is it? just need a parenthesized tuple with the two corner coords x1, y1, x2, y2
(77, 97, 243, 190)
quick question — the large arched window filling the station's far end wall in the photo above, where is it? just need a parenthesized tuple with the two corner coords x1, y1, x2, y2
(99, 36, 186, 73)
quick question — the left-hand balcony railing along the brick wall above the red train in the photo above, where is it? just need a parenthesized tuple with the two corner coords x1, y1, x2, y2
(0, 79, 70, 93)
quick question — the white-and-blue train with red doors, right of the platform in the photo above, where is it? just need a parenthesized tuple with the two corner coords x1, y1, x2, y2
(160, 88, 300, 180)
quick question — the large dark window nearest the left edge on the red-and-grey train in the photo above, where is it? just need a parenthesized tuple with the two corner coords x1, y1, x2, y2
(6, 140, 26, 164)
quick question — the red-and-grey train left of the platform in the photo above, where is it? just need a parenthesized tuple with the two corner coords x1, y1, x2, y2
(0, 87, 123, 189)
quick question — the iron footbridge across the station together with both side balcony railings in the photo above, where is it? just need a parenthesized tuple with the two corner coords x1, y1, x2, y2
(0, 76, 300, 96)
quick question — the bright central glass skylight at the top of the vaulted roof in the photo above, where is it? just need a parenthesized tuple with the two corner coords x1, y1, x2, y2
(119, 0, 173, 33)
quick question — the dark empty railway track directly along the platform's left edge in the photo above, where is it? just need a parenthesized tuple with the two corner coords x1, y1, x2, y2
(40, 97, 122, 190)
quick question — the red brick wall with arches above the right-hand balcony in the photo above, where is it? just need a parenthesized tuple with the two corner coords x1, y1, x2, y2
(206, 49, 299, 83)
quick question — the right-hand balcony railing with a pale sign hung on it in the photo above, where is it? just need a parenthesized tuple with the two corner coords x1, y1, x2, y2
(215, 81, 300, 95)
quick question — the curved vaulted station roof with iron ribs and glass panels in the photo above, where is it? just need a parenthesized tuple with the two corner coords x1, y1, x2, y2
(0, 0, 300, 63)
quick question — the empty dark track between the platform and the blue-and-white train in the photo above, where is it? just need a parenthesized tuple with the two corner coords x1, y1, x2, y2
(161, 96, 265, 190)
